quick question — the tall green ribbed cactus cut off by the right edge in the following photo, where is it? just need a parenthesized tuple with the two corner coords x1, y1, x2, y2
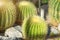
(48, 0, 60, 26)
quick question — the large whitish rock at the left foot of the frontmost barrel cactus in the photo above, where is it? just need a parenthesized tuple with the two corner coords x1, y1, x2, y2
(5, 26, 22, 38)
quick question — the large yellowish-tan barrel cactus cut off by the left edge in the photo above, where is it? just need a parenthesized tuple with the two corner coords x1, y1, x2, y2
(0, 1, 16, 31)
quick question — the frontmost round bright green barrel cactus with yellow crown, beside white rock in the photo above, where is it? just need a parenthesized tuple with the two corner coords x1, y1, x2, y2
(22, 16, 48, 40)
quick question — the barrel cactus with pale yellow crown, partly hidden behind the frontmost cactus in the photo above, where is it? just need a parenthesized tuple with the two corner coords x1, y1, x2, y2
(17, 1, 37, 24)
